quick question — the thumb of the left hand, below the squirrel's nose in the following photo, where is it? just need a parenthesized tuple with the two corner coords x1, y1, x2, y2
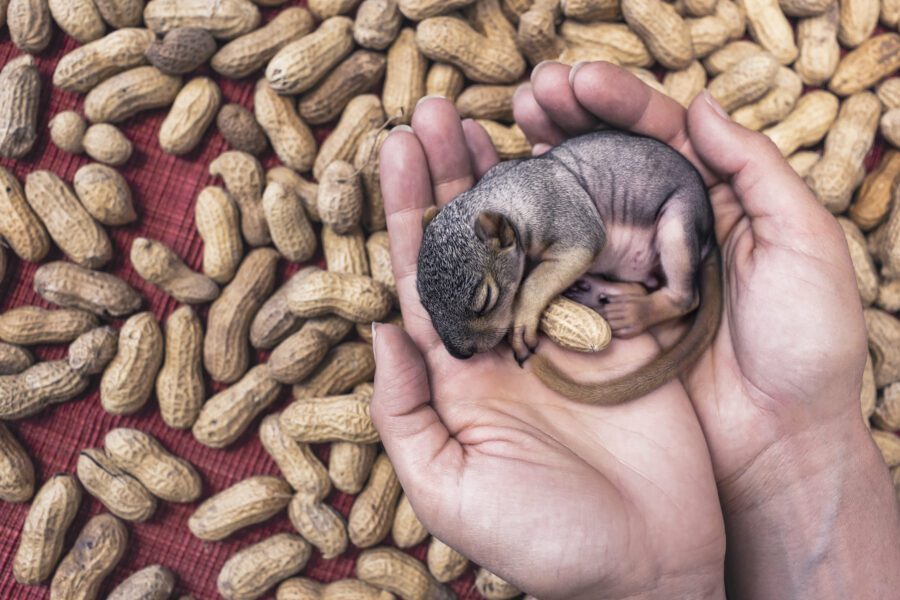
(371, 325, 462, 509)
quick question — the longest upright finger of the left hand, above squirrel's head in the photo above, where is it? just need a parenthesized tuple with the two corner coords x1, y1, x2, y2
(412, 97, 475, 206)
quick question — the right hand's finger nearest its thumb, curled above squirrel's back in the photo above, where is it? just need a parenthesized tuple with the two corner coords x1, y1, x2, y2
(572, 62, 715, 185)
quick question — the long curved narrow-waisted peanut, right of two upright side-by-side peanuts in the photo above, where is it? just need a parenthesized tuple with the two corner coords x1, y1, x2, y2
(203, 248, 280, 383)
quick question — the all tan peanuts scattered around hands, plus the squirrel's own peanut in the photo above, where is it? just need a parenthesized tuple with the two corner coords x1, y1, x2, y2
(0, 0, 900, 600)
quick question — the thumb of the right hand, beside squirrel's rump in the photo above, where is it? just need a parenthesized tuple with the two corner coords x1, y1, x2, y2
(687, 90, 828, 224)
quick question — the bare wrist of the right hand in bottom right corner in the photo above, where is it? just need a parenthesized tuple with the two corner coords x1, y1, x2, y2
(719, 413, 900, 598)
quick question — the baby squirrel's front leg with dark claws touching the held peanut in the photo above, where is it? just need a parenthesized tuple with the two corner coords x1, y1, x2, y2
(509, 248, 596, 365)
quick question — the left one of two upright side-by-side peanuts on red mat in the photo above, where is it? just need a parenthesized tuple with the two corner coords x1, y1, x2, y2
(100, 312, 163, 415)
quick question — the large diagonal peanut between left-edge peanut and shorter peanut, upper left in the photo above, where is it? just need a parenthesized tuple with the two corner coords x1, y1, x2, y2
(25, 171, 112, 268)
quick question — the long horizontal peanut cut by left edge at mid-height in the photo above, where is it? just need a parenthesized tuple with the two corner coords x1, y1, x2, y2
(0, 306, 98, 346)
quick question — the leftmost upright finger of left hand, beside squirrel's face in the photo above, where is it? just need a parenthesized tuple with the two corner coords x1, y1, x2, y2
(380, 128, 438, 351)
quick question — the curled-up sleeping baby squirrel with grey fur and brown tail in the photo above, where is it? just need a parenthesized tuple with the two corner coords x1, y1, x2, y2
(416, 130, 722, 405)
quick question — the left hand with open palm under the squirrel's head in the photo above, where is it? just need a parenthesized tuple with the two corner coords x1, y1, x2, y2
(371, 99, 724, 600)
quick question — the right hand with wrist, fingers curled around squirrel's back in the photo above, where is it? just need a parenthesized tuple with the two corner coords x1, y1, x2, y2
(514, 63, 897, 598)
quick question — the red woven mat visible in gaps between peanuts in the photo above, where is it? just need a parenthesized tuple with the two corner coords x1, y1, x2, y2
(0, 5, 480, 600)
